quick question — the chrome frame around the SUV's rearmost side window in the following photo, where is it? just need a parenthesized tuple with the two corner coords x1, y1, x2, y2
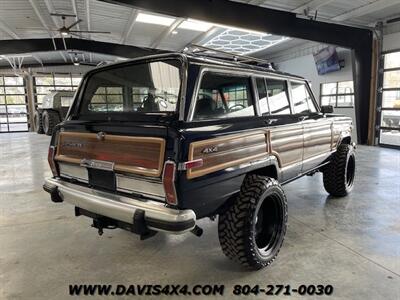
(187, 67, 260, 123)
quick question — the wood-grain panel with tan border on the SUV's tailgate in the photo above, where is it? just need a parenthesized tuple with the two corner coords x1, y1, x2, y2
(56, 132, 165, 176)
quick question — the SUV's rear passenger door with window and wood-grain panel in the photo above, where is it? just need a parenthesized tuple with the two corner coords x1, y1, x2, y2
(256, 78, 303, 181)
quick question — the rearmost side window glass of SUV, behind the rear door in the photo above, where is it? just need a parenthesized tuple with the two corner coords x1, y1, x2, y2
(193, 72, 254, 120)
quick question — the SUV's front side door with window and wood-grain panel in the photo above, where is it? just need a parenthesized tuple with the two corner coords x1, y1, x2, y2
(290, 81, 332, 173)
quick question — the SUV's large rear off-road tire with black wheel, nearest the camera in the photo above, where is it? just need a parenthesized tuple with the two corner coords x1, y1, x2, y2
(218, 175, 287, 270)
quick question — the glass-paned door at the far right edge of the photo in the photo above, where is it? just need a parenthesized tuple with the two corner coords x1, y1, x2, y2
(378, 51, 400, 148)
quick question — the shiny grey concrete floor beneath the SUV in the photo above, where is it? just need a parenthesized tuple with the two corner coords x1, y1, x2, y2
(0, 133, 400, 299)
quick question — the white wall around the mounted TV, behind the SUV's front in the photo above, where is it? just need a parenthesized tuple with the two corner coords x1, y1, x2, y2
(277, 49, 357, 140)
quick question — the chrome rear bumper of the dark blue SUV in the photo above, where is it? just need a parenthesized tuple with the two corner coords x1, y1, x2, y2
(45, 178, 196, 233)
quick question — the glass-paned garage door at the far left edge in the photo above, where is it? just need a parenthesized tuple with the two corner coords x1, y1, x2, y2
(0, 75, 29, 133)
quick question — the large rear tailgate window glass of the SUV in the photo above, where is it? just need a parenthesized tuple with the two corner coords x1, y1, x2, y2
(80, 59, 181, 115)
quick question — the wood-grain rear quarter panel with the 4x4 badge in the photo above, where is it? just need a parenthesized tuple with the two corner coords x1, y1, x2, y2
(187, 131, 269, 179)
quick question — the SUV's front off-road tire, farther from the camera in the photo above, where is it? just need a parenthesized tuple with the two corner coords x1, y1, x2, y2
(323, 144, 355, 197)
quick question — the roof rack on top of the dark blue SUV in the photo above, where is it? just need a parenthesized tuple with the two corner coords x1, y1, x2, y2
(183, 44, 273, 70)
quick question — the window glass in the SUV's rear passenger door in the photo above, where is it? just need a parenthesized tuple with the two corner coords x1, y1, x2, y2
(266, 78, 290, 115)
